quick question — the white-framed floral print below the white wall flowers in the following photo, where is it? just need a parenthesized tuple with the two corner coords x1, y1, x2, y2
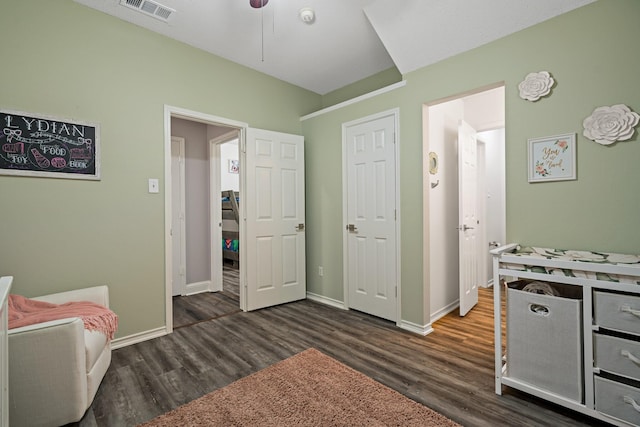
(529, 133, 576, 182)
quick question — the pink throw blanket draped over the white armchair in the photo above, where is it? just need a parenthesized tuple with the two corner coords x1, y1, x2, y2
(8, 294, 118, 340)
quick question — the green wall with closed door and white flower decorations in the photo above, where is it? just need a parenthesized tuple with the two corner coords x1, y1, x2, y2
(303, 0, 640, 324)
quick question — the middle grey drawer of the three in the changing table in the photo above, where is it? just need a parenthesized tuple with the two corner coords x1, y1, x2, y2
(594, 334, 640, 381)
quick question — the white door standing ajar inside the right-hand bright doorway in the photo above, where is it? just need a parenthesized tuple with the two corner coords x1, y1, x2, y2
(458, 120, 479, 316)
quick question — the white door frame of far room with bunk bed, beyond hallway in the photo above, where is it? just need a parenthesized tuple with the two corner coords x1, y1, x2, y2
(209, 129, 242, 292)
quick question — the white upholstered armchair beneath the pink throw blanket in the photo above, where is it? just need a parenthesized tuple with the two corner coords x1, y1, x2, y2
(9, 286, 111, 427)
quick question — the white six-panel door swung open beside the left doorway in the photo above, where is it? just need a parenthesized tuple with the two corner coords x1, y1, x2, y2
(240, 128, 306, 310)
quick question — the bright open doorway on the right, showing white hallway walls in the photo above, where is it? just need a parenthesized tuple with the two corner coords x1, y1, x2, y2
(423, 84, 506, 324)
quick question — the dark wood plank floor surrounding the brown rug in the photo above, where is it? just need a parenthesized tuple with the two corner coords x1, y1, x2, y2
(71, 271, 598, 426)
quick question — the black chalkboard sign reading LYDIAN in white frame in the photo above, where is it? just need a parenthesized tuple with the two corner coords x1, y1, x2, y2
(0, 110, 100, 179)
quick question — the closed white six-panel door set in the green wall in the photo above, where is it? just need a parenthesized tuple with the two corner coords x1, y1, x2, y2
(345, 115, 397, 321)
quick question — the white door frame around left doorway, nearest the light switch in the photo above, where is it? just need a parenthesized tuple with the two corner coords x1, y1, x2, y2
(164, 104, 249, 333)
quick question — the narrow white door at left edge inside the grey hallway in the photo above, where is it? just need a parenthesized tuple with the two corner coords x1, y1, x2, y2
(171, 137, 187, 296)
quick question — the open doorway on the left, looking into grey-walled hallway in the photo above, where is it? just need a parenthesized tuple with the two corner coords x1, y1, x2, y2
(165, 107, 247, 332)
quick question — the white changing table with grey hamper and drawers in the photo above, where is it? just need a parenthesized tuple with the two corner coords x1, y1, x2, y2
(491, 244, 640, 426)
